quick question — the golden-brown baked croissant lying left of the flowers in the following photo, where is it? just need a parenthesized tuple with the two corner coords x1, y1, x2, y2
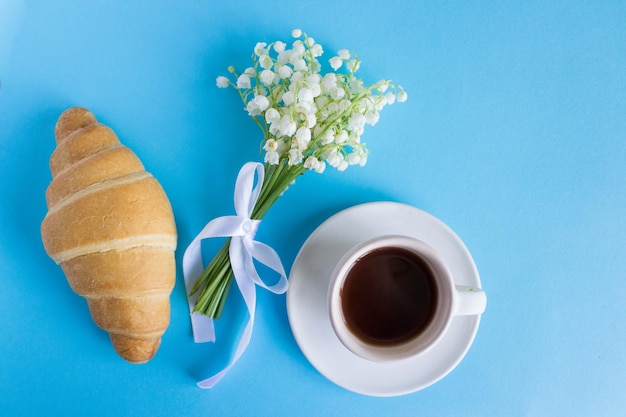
(41, 107, 177, 363)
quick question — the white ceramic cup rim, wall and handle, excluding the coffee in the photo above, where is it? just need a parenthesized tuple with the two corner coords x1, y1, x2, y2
(328, 235, 487, 362)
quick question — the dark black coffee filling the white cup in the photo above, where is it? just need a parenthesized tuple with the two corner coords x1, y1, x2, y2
(341, 248, 437, 346)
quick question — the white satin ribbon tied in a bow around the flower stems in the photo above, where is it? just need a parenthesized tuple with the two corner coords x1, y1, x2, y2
(183, 162, 288, 388)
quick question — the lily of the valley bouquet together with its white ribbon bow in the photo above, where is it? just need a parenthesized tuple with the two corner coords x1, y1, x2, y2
(183, 29, 407, 388)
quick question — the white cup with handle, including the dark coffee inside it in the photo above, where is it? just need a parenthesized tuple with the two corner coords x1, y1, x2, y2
(328, 235, 487, 362)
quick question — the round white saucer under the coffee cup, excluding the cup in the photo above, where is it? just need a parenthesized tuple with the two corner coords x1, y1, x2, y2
(287, 202, 481, 397)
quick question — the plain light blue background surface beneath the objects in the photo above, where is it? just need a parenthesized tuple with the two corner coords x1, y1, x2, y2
(0, 0, 626, 416)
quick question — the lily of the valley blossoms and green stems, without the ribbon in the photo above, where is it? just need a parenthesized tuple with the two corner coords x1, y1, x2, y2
(191, 29, 407, 318)
